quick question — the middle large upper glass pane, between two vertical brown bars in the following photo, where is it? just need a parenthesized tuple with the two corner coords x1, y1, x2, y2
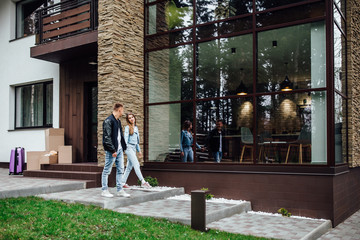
(197, 34, 253, 98)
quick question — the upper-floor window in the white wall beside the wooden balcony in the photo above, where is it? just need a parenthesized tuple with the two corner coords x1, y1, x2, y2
(16, 0, 50, 38)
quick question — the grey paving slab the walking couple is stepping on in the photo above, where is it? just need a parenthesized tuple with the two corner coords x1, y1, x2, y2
(38, 188, 184, 209)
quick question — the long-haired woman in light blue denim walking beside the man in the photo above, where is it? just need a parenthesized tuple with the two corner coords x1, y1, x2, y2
(122, 113, 151, 188)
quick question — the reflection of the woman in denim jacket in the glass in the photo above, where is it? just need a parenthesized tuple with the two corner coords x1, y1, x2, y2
(180, 120, 201, 162)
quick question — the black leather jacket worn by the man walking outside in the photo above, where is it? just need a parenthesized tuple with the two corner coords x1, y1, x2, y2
(103, 114, 126, 153)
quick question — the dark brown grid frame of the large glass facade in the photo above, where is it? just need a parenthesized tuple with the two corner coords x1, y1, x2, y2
(144, 0, 348, 169)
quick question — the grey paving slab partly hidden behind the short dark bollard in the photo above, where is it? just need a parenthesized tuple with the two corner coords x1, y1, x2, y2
(114, 199, 251, 225)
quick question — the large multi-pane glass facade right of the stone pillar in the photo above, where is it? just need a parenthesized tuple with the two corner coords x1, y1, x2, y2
(145, 0, 347, 165)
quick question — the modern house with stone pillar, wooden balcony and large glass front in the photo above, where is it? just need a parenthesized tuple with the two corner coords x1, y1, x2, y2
(0, 0, 360, 225)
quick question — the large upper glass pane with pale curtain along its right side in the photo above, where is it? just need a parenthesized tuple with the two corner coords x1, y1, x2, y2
(257, 22, 326, 92)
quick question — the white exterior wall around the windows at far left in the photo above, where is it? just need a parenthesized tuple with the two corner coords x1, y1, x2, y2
(0, 0, 59, 162)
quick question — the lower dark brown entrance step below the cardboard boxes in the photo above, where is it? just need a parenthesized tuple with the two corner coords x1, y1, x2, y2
(23, 170, 101, 188)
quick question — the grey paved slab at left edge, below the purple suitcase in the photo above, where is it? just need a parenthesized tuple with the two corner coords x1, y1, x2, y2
(0, 168, 86, 199)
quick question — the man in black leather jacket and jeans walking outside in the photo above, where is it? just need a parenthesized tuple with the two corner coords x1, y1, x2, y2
(101, 103, 130, 197)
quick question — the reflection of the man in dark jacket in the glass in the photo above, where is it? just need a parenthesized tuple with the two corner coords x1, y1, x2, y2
(206, 119, 227, 163)
